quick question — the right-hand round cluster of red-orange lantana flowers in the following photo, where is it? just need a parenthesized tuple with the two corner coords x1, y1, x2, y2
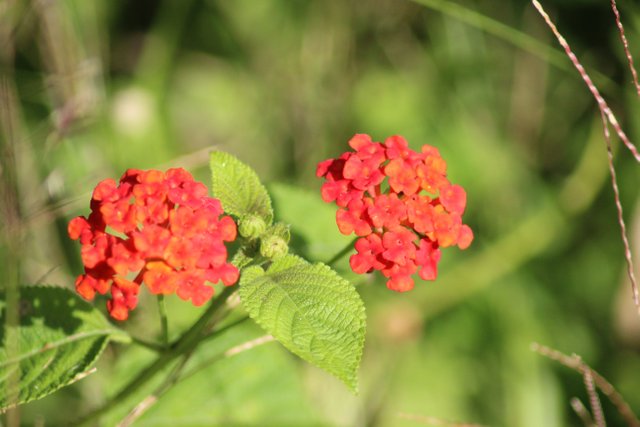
(316, 134, 473, 292)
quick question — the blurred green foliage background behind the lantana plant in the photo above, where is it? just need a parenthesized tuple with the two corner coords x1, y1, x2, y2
(0, 0, 640, 426)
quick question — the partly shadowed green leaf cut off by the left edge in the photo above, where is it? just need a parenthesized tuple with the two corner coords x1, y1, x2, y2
(0, 286, 130, 409)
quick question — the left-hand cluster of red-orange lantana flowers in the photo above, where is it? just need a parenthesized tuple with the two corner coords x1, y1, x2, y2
(68, 169, 239, 320)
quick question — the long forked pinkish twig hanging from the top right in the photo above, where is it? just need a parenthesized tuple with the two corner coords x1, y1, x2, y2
(532, 0, 640, 313)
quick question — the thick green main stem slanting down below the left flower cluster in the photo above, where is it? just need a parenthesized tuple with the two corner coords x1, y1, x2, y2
(76, 287, 235, 426)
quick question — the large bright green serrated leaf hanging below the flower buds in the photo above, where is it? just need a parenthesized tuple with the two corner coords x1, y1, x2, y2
(239, 255, 366, 393)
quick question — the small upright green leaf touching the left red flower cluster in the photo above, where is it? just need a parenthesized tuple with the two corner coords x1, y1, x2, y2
(209, 151, 273, 225)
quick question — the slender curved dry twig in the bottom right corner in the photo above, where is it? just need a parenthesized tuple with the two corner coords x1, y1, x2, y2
(531, 343, 640, 427)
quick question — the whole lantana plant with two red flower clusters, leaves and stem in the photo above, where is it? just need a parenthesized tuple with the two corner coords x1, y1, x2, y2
(0, 134, 473, 424)
